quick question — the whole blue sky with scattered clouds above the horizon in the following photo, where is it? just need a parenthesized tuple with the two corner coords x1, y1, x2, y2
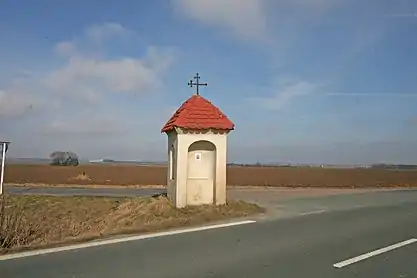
(0, 0, 417, 164)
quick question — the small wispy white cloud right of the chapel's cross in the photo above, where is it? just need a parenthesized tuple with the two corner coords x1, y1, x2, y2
(248, 80, 321, 110)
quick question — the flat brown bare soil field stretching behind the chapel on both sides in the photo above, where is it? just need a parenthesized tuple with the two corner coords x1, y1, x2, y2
(5, 165, 417, 188)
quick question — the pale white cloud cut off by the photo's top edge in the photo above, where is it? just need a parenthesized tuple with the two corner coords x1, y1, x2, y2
(172, 0, 267, 38)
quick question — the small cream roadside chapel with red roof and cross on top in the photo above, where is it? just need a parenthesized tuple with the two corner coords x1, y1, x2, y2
(161, 73, 234, 208)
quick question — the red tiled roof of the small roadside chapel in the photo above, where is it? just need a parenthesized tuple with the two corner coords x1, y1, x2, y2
(161, 95, 235, 132)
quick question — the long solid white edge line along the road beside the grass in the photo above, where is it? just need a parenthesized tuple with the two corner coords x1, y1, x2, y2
(0, 220, 256, 261)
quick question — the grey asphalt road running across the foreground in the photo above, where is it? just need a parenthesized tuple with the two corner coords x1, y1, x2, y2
(0, 191, 417, 278)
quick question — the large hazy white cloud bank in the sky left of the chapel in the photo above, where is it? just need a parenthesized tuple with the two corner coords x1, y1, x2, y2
(0, 23, 176, 151)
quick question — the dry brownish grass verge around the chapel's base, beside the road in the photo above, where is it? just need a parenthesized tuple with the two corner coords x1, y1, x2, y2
(0, 195, 264, 253)
